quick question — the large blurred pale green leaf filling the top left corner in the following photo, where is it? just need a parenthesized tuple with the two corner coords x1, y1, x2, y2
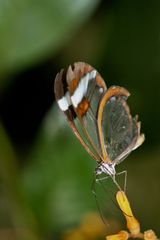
(0, 0, 99, 77)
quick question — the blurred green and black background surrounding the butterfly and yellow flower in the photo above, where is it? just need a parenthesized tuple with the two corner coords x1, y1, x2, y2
(0, 0, 160, 240)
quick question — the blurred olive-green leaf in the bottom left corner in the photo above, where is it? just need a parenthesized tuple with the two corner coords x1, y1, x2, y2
(0, 123, 40, 240)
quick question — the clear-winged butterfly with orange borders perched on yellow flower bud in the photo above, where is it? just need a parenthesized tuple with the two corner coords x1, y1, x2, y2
(54, 62, 144, 186)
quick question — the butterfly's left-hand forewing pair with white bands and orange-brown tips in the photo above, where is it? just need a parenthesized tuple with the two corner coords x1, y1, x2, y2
(55, 63, 106, 161)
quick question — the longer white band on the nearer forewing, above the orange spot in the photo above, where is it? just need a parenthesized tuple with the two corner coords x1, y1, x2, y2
(71, 70, 96, 108)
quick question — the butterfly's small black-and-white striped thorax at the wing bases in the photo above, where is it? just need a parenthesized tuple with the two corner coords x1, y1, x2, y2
(95, 162, 116, 176)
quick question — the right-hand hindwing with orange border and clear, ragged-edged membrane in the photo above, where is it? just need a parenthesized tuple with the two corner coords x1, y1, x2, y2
(98, 87, 142, 164)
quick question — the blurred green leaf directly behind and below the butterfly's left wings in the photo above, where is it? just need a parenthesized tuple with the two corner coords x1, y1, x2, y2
(23, 105, 96, 230)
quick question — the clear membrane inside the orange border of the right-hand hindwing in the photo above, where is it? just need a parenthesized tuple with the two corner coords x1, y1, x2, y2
(102, 97, 138, 161)
